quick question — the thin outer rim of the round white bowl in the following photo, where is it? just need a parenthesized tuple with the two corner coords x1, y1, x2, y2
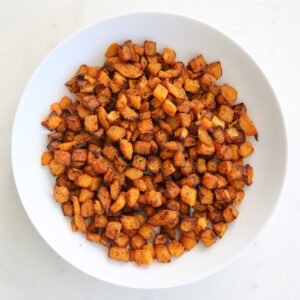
(10, 10, 288, 290)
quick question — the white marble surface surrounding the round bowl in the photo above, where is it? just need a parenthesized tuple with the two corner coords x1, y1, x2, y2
(0, 0, 300, 300)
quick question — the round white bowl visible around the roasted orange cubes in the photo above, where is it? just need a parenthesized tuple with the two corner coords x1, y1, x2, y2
(12, 13, 287, 288)
